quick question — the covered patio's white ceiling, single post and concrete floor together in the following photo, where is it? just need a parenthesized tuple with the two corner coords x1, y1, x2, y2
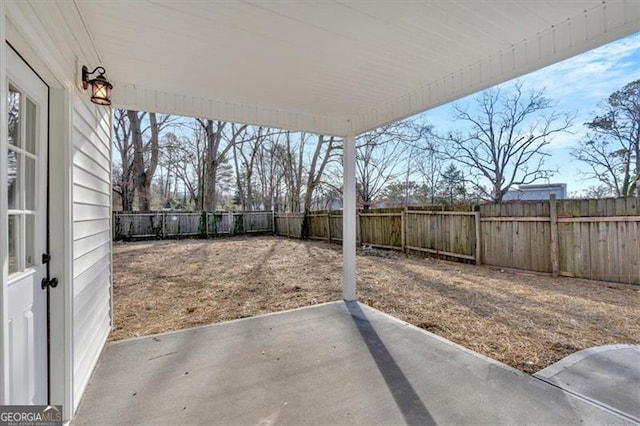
(75, 1, 640, 424)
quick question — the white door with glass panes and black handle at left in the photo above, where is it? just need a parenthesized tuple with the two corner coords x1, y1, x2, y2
(2, 46, 48, 404)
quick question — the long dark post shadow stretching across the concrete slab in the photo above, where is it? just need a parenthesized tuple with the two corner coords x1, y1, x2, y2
(345, 302, 436, 425)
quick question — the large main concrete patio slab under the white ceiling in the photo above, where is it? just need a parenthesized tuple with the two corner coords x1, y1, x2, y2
(74, 302, 633, 425)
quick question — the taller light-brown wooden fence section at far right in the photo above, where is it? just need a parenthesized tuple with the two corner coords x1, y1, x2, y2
(480, 197, 640, 284)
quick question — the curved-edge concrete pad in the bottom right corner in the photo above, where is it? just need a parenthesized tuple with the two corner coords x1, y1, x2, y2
(535, 345, 640, 423)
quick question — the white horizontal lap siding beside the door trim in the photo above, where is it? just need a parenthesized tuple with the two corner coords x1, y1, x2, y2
(71, 104, 111, 406)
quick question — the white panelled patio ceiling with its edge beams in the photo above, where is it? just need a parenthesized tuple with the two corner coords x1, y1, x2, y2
(76, 0, 640, 135)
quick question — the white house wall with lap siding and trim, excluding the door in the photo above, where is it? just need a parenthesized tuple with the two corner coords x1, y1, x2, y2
(0, 1, 112, 419)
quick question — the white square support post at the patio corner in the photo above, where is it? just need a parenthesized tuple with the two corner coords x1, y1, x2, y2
(342, 136, 356, 301)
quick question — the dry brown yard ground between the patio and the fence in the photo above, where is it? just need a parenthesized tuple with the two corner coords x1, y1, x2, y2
(110, 237, 640, 373)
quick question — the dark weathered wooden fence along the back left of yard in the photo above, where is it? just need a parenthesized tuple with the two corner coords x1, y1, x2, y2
(112, 211, 274, 240)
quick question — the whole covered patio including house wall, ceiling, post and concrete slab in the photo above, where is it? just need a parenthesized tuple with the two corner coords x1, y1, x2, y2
(0, 0, 640, 424)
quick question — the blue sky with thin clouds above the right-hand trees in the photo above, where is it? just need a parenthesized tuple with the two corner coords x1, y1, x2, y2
(422, 33, 640, 193)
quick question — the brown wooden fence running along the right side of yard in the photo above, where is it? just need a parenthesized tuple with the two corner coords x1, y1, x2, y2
(275, 197, 640, 284)
